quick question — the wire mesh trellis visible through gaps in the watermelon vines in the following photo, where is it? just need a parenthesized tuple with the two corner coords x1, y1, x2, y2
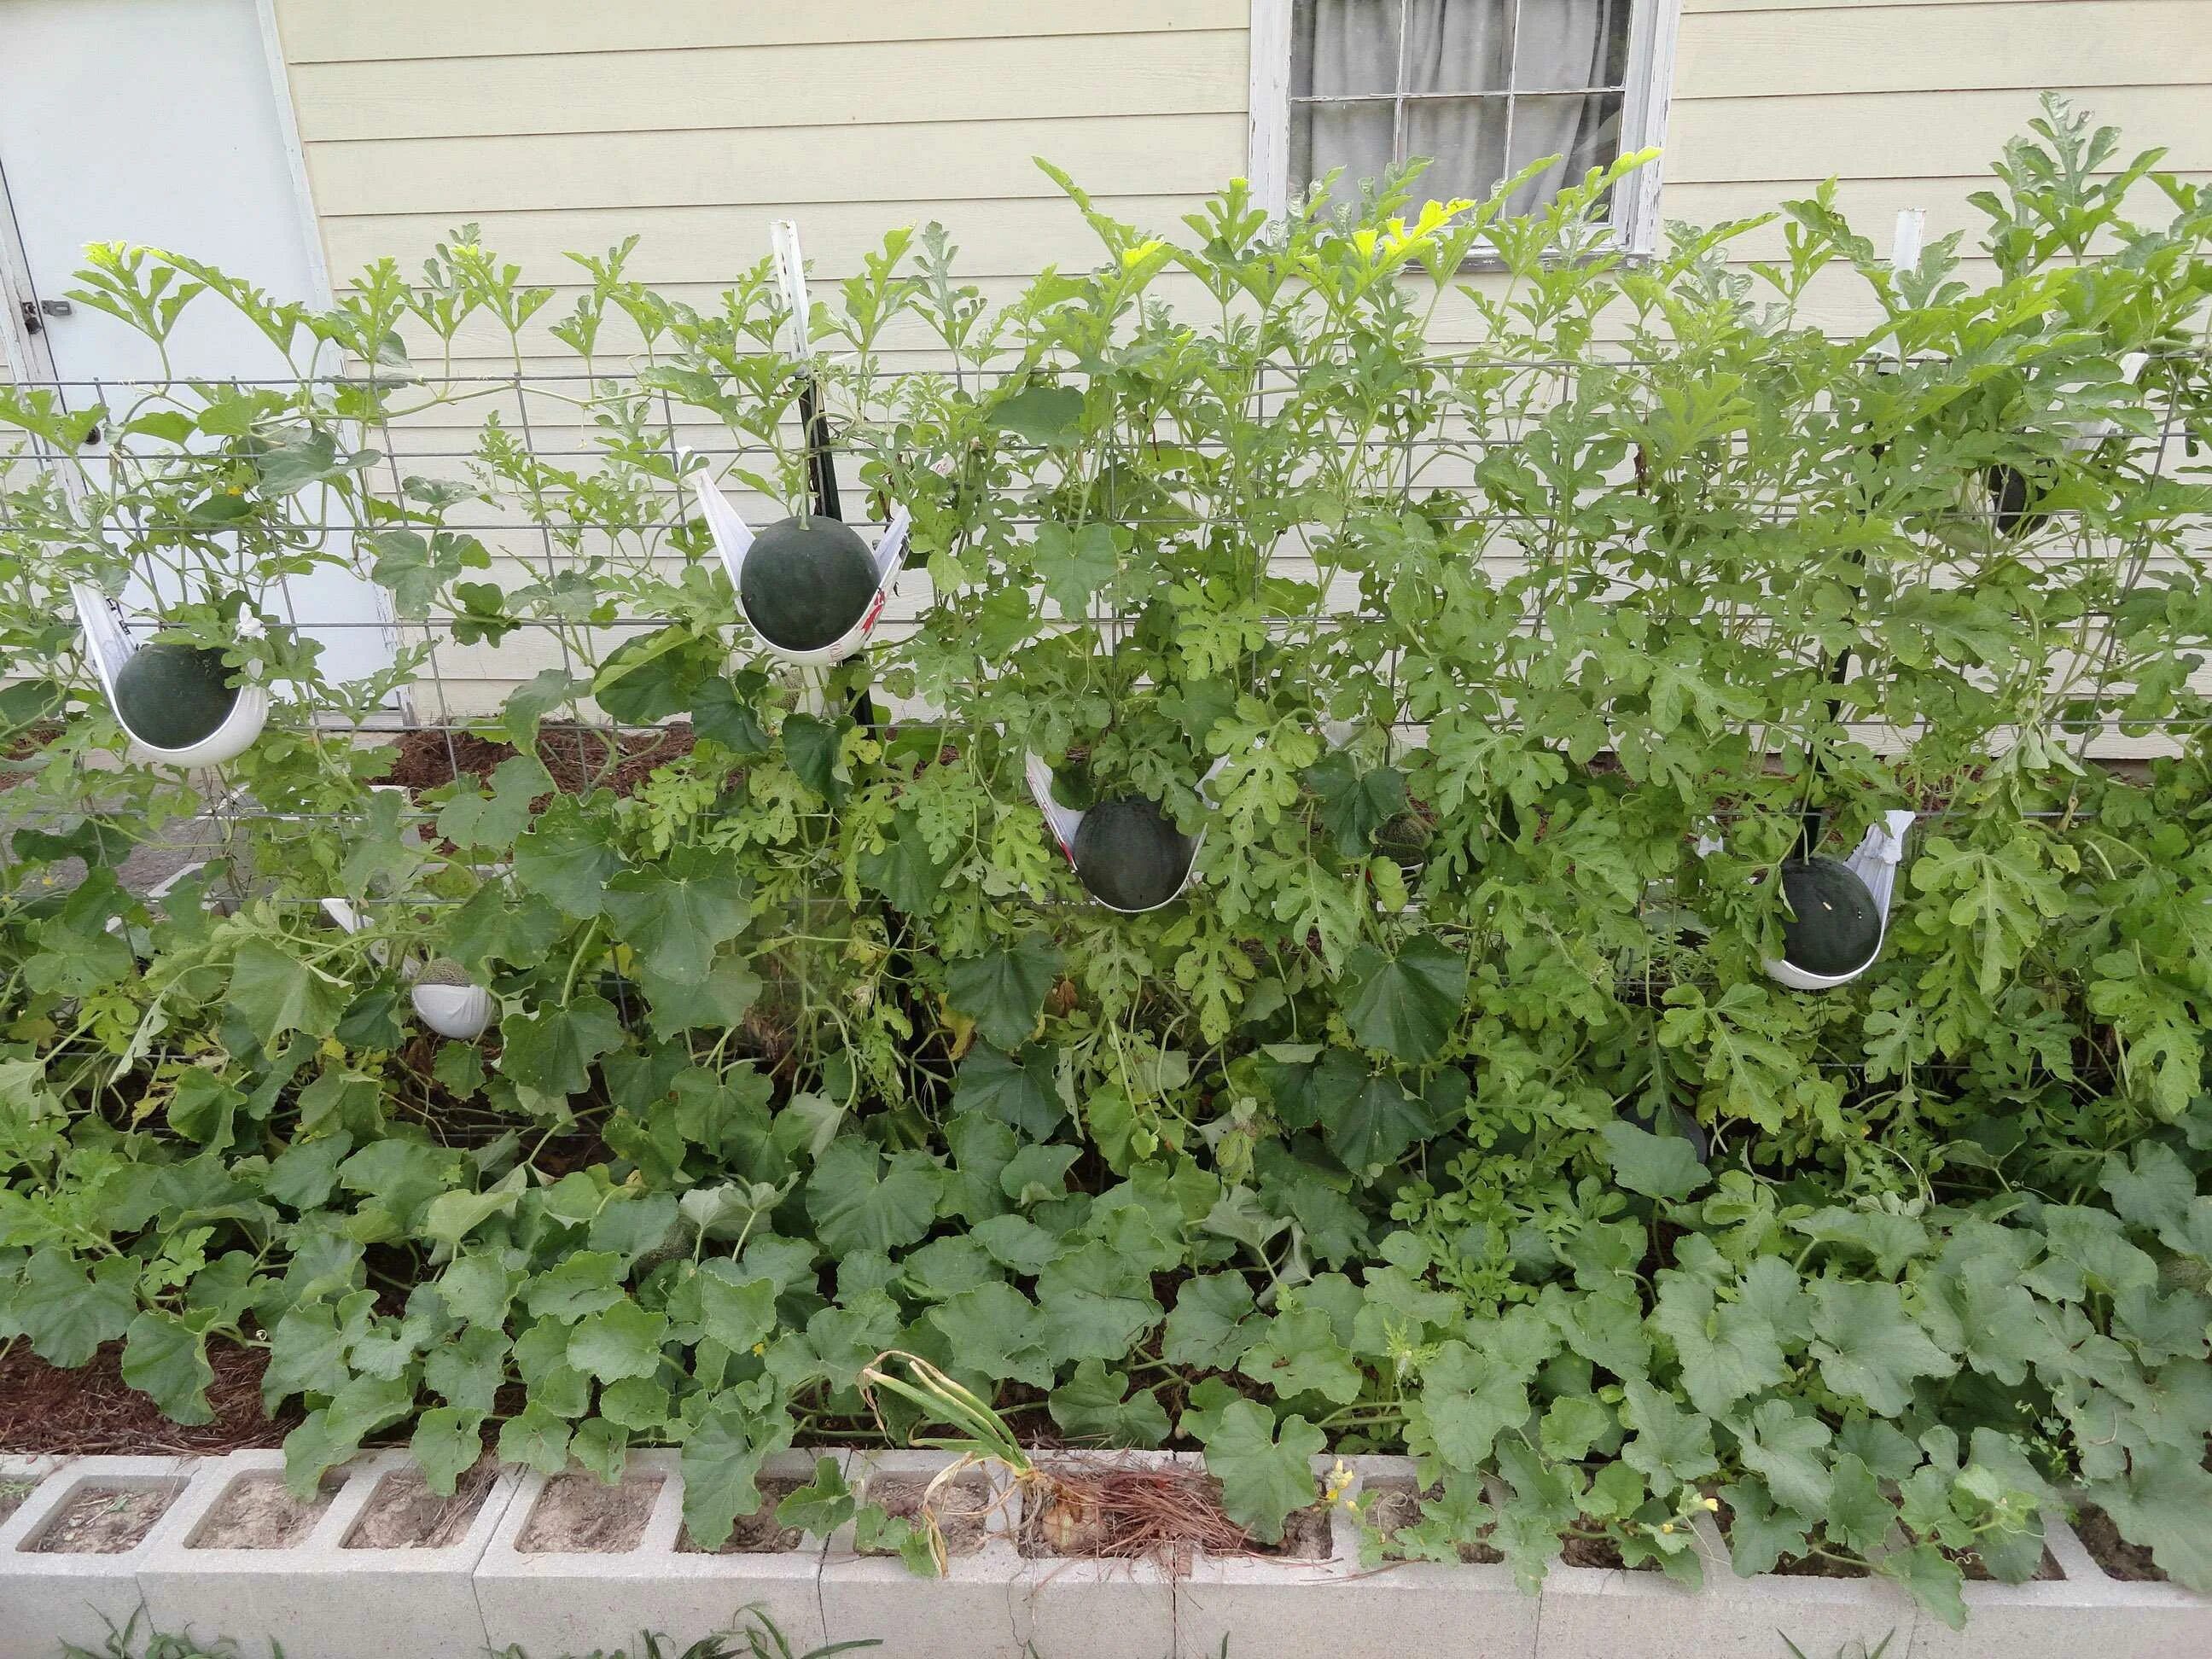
(0, 350, 2203, 884)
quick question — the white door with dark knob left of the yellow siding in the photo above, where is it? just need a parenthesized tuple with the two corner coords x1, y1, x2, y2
(0, 0, 392, 679)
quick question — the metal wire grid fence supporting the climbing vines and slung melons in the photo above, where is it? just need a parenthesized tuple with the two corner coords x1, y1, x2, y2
(0, 352, 2212, 871)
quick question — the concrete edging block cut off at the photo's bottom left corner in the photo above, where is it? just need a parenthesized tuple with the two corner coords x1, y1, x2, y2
(0, 1458, 193, 1659)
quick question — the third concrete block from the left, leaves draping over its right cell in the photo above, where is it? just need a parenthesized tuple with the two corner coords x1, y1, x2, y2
(475, 1451, 843, 1659)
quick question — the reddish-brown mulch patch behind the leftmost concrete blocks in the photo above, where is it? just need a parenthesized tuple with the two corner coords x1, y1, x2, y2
(0, 1341, 301, 1456)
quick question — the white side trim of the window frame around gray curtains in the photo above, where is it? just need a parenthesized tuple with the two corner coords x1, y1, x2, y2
(1248, 0, 1681, 254)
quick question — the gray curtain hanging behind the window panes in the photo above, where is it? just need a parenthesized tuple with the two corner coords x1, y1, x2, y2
(1289, 0, 1630, 212)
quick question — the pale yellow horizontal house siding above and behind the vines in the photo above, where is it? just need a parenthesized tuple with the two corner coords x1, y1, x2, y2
(263, 0, 2212, 713)
